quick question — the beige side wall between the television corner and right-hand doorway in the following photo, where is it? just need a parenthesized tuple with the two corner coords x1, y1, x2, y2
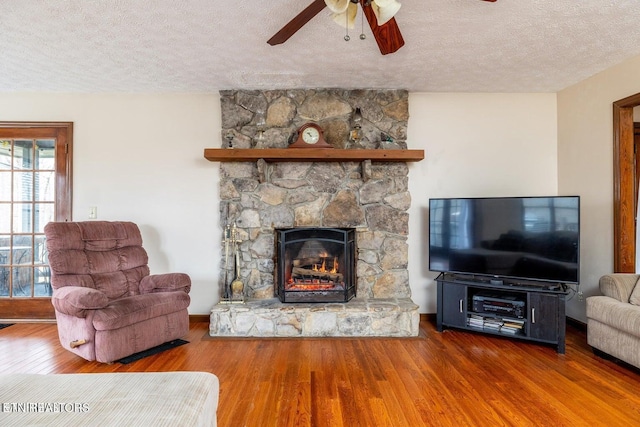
(558, 57, 640, 322)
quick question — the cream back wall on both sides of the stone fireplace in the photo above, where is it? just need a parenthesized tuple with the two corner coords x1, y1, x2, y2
(0, 93, 557, 314)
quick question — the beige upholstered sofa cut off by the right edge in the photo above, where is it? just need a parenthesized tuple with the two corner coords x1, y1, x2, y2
(587, 273, 640, 368)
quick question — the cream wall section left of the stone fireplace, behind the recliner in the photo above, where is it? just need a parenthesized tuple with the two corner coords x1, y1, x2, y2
(0, 94, 221, 314)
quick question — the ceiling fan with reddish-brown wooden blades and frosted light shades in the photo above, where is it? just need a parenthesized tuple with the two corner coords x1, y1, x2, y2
(267, 0, 496, 55)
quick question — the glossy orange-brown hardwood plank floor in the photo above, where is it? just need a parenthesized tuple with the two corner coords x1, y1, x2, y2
(0, 321, 640, 427)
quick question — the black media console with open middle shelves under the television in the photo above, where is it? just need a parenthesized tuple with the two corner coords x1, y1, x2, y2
(436, 273, 566, 354)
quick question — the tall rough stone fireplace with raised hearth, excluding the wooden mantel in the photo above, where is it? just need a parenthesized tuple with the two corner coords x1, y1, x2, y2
(210, 90, 419, 336)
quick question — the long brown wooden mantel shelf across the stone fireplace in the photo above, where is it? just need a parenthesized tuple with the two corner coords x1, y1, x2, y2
(204, 148, 424, 162)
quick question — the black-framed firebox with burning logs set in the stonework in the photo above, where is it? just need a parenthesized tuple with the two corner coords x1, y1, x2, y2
(275, 227, 356, 303)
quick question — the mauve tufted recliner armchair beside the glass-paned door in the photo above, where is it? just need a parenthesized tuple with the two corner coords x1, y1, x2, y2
(44, 221, 191, 363)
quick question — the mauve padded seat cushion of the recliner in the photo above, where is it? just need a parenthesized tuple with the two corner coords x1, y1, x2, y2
(93, 291, 190, 331)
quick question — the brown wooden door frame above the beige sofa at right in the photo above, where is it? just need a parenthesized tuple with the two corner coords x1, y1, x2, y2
(613, 93, 640, 273)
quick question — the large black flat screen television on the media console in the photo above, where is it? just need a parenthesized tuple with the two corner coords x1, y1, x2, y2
(429, 196, 580, 284)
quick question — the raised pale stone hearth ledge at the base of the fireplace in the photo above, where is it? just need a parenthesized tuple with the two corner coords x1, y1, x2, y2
(209, 298, 420, 337)
